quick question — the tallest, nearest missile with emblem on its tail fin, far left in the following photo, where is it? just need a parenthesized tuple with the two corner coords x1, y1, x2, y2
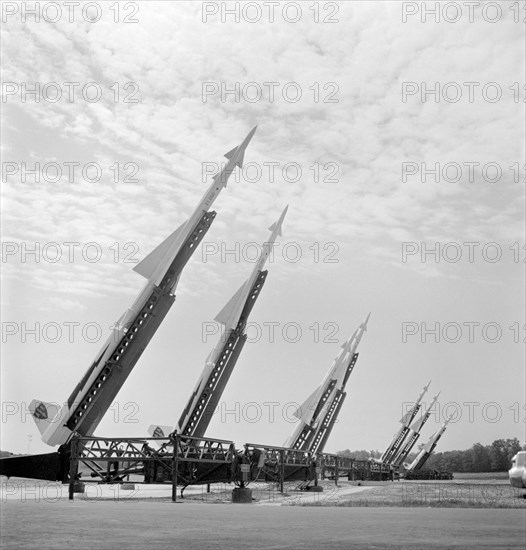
(29, 127, 257, 446)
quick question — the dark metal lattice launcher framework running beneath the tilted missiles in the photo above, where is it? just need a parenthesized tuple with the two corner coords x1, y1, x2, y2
(58, 434, 393, 502)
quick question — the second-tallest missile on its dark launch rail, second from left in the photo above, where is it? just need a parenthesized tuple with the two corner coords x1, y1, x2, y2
(148, 206, 288, 437)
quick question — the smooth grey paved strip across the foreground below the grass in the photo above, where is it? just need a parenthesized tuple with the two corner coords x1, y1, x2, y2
(1, 499, 526, 550)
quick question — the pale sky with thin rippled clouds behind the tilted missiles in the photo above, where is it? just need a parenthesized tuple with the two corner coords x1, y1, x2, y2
(0, 1, 526, 453)
